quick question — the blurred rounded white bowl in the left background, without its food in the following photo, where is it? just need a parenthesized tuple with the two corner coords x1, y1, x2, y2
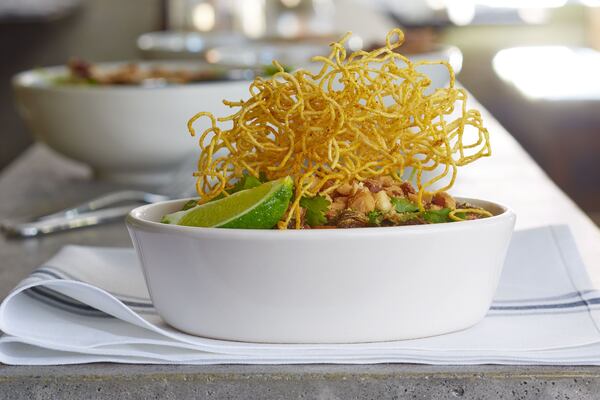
(13, 62, 249, 184)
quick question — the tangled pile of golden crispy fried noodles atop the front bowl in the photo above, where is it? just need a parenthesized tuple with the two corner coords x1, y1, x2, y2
(188, 29, 491, 229)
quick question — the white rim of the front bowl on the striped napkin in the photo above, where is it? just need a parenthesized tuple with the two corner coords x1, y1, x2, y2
(125, 197, 516, 240)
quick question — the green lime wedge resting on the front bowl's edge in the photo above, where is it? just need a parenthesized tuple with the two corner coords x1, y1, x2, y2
(161, 176, 294, 229)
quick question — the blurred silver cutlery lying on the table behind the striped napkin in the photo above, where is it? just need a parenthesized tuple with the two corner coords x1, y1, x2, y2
(0, 157, 195, 237)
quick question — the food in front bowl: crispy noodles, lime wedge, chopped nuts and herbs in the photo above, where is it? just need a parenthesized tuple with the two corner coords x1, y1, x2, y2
(163, 29, 492, 229)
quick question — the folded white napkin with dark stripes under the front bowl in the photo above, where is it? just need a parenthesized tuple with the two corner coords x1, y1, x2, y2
(0, 226, 600, 365)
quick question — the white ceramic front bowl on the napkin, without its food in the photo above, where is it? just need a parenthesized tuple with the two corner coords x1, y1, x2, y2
(127, 199, 515, 343)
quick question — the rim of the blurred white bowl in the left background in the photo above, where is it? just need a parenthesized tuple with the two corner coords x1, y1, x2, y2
(11, 59, 252, 93)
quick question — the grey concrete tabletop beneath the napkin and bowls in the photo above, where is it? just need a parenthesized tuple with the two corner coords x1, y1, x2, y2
(0, 97, 600, 398)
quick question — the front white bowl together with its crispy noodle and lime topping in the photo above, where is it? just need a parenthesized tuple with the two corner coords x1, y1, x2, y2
(127, 30, 515, 343)
